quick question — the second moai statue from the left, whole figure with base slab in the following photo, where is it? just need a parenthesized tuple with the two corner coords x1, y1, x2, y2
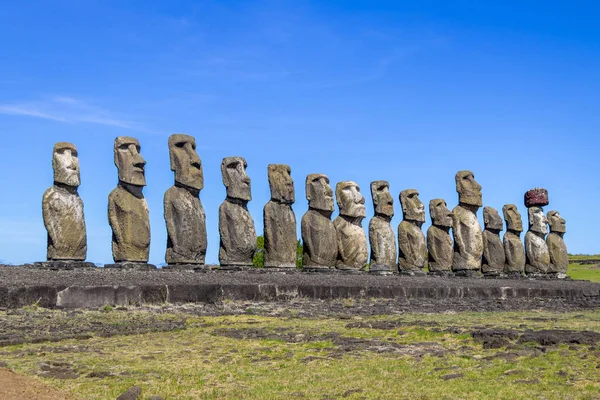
(105, 136, 156, 269)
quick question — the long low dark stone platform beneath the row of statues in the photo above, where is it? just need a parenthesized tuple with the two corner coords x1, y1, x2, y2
(0, 267, 600, 312)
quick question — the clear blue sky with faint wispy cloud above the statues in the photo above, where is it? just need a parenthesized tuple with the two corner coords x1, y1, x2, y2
(0, 0, 600, 264)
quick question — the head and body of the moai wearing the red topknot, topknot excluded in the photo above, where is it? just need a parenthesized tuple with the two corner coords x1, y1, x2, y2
(525, 207, 554, 274)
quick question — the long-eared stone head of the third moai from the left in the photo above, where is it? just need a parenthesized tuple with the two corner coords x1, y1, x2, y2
(169, 134, 204, 190)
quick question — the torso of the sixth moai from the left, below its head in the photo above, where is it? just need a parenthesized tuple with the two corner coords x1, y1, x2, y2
(301, 209, 338, 268)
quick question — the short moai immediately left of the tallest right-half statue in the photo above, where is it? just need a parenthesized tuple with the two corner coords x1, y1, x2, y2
(427, 199, 453, 275)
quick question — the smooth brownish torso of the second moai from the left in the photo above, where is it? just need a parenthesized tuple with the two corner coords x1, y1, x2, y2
(108, 185, 150, 263)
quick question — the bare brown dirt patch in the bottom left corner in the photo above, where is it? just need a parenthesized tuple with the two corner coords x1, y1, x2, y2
(0, 368, 76, 400)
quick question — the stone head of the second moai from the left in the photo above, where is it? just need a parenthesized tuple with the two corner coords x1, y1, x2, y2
(114, 136, 146, 186)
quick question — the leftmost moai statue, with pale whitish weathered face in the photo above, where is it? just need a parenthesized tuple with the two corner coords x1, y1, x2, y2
(42, 142, 87, 261)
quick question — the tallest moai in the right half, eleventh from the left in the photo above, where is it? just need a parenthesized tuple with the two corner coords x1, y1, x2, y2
(452, 171, 483, 275)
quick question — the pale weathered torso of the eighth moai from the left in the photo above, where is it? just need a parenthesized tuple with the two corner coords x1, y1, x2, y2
(369, 215, 398, 271)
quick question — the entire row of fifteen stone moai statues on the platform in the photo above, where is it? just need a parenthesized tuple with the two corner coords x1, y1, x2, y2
(37, 134, 568, 276)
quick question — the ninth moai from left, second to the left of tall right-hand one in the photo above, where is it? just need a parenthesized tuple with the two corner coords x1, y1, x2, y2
(398, 189, 427, 275)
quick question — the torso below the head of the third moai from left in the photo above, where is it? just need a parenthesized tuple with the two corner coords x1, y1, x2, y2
(164, 186, 207, 264)
